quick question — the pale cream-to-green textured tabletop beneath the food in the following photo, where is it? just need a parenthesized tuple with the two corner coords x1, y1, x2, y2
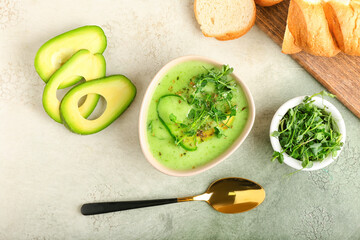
(0, 0, 360, 239)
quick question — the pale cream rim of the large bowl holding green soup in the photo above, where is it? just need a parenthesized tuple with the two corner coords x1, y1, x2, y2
(139, 56, 255, 176)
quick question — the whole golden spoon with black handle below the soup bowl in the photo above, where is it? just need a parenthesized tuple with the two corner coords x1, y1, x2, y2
(81, 177, 265, 215)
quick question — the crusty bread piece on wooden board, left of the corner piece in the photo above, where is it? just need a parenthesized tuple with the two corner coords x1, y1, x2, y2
(287, 0, 340, 57)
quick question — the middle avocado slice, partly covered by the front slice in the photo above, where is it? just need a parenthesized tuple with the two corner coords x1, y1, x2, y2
(42, 50, 106, 123)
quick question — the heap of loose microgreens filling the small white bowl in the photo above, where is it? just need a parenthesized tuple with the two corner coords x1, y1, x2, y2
(271, 91, 343, 168)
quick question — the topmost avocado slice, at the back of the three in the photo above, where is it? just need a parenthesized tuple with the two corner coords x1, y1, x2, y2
(34, 26, 107, 82)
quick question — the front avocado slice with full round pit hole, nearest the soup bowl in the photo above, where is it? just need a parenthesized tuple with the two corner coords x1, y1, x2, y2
(60, 75, 136, 135)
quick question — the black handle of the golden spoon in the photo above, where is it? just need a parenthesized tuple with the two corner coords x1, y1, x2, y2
(81, 198, 178, 215)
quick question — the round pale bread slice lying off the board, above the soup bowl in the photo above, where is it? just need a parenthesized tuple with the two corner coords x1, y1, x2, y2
(194, 0, 256, 41)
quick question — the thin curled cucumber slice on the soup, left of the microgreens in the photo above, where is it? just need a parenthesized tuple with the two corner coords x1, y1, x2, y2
(156, 94, 197, 151)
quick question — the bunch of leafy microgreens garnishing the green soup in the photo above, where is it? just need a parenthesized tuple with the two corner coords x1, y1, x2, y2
(169, 65, 237, 144)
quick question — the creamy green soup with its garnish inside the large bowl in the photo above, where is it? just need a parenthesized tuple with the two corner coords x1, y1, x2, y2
(147, 61, 248, 170)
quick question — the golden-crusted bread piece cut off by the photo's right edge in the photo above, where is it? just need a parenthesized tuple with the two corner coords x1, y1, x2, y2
(323, 0, 360, 56)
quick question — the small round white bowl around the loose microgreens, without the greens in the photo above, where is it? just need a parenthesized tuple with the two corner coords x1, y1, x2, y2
(270, 96, 346, 171)
